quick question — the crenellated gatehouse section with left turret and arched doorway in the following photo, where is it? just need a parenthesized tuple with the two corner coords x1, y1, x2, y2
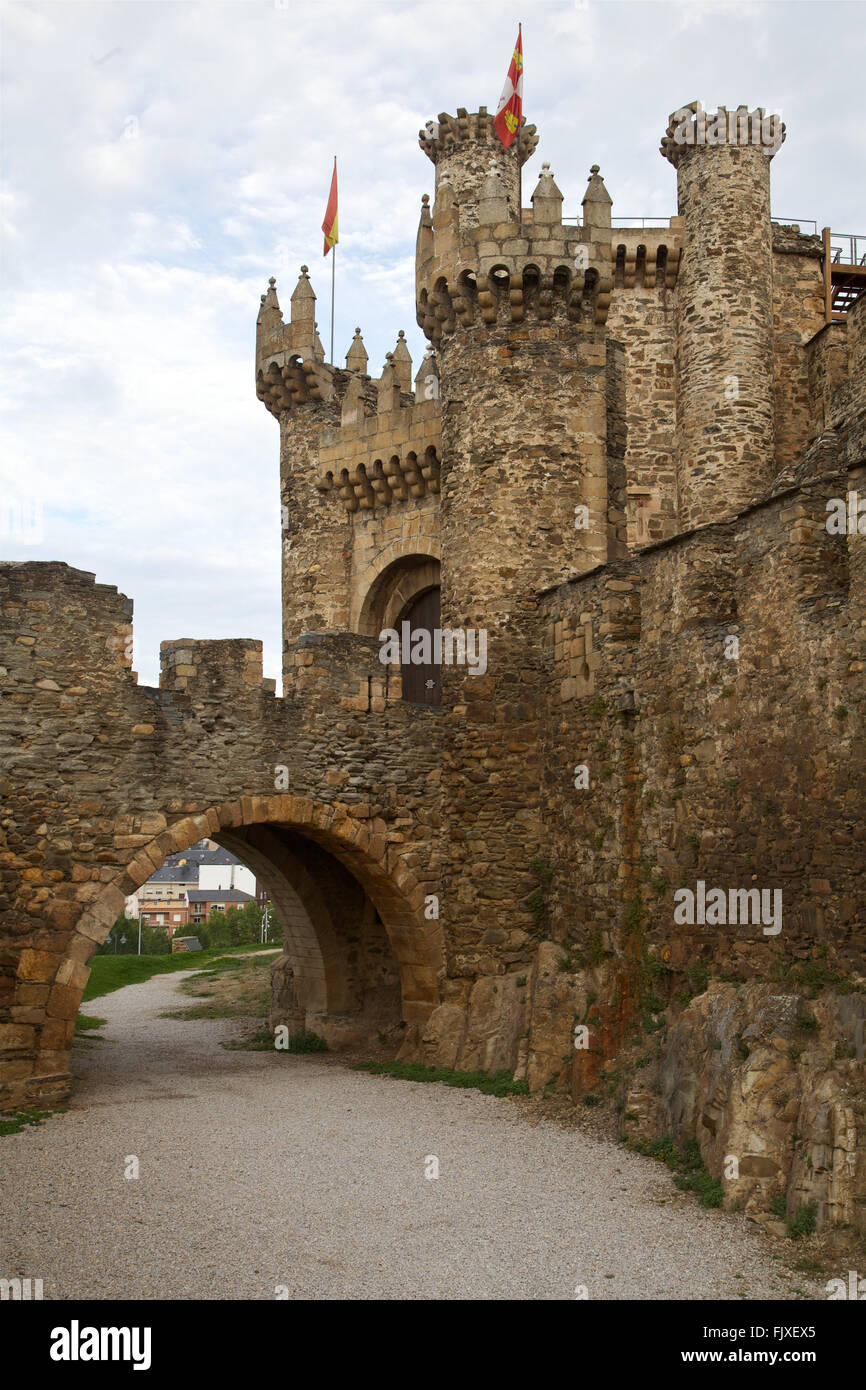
(256, 265, 441, 689)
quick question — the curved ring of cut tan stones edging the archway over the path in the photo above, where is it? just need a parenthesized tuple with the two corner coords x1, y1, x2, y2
(0, 795, 442, 1106)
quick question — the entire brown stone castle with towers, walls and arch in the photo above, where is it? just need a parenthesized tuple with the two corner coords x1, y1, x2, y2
(0, 104, 866, 1232)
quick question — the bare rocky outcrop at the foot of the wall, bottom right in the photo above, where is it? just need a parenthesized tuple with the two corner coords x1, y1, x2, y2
(627, 983, 866, 1233)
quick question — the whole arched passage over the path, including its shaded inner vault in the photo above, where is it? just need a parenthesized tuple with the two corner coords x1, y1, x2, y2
(0, 795, 442, 1098)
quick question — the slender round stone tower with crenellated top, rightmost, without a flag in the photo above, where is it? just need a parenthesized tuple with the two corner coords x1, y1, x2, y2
(662, 101, 784, 527)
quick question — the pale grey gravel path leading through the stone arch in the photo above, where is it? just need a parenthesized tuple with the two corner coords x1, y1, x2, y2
(0, 974, 819, 1300)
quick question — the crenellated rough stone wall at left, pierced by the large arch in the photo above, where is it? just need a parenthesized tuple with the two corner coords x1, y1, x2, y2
(0, 564, 441, 1105)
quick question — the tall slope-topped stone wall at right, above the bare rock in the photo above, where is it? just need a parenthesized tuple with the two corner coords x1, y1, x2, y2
(542, 470, 866, 979)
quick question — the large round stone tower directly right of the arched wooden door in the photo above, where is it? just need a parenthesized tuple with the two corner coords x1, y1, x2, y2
(416, 110, 612, 977)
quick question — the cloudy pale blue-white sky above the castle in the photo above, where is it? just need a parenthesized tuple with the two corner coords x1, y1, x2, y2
(0, 0, 866, 689)
